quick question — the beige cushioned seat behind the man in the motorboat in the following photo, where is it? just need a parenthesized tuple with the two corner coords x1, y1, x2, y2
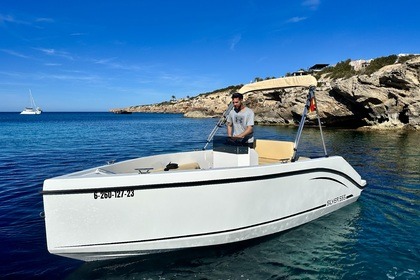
(254, 139, 294, 164)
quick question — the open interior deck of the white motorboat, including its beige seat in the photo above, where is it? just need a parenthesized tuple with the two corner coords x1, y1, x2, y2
(67, 139, 302, 177)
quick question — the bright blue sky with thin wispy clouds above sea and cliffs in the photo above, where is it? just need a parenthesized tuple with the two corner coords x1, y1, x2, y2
(0, 0, 420, 112)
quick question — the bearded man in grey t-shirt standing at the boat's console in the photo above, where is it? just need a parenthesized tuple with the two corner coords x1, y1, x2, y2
(227, 92, 254, 148)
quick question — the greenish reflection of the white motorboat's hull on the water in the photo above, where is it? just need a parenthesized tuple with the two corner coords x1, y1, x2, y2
(69, 204, 361, 279)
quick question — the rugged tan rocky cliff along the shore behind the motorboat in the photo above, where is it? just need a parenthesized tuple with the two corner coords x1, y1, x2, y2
(111, 56, 420, 130)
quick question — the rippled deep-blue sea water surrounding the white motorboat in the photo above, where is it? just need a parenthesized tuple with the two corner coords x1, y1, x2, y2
(0, 113, 420, 279)
